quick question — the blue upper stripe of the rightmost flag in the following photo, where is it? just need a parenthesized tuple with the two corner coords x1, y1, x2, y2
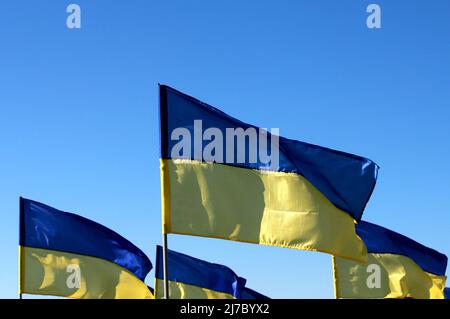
(356, 221, 447, 276)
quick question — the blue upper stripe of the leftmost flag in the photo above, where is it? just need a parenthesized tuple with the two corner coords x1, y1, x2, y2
(20, 198, 152, 281)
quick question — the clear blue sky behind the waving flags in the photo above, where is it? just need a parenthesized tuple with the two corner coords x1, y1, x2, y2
(0, 0, 450, 298)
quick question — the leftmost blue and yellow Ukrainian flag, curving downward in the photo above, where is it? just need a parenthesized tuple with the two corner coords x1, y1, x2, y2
(19, 198, 153, 299)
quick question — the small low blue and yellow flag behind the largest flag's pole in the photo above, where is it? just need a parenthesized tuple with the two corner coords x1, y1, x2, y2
(155, 246, 246, 299)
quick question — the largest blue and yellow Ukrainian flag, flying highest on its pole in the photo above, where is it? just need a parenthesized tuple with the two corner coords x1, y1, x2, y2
(160, 85, 378, 261)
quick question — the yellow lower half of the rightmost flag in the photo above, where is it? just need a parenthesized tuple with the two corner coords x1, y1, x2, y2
(333, 254, 446, 299)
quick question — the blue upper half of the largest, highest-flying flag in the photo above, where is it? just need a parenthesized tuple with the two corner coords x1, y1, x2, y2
(160, 85, 378, 220)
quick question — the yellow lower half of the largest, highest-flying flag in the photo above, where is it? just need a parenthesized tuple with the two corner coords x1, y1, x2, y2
(163, 160, 367, 261)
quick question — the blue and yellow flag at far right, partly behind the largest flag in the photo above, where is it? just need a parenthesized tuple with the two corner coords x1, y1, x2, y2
(333, 221, 447, 299)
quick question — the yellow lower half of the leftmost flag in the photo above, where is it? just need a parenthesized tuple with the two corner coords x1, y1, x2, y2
(19, 248, 153, 299)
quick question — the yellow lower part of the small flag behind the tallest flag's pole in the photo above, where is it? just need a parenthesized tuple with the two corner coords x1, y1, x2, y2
(155, 278, 236, 299)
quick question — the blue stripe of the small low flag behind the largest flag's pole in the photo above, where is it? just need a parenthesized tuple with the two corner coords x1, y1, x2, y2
(155, 246, 246, 299)
